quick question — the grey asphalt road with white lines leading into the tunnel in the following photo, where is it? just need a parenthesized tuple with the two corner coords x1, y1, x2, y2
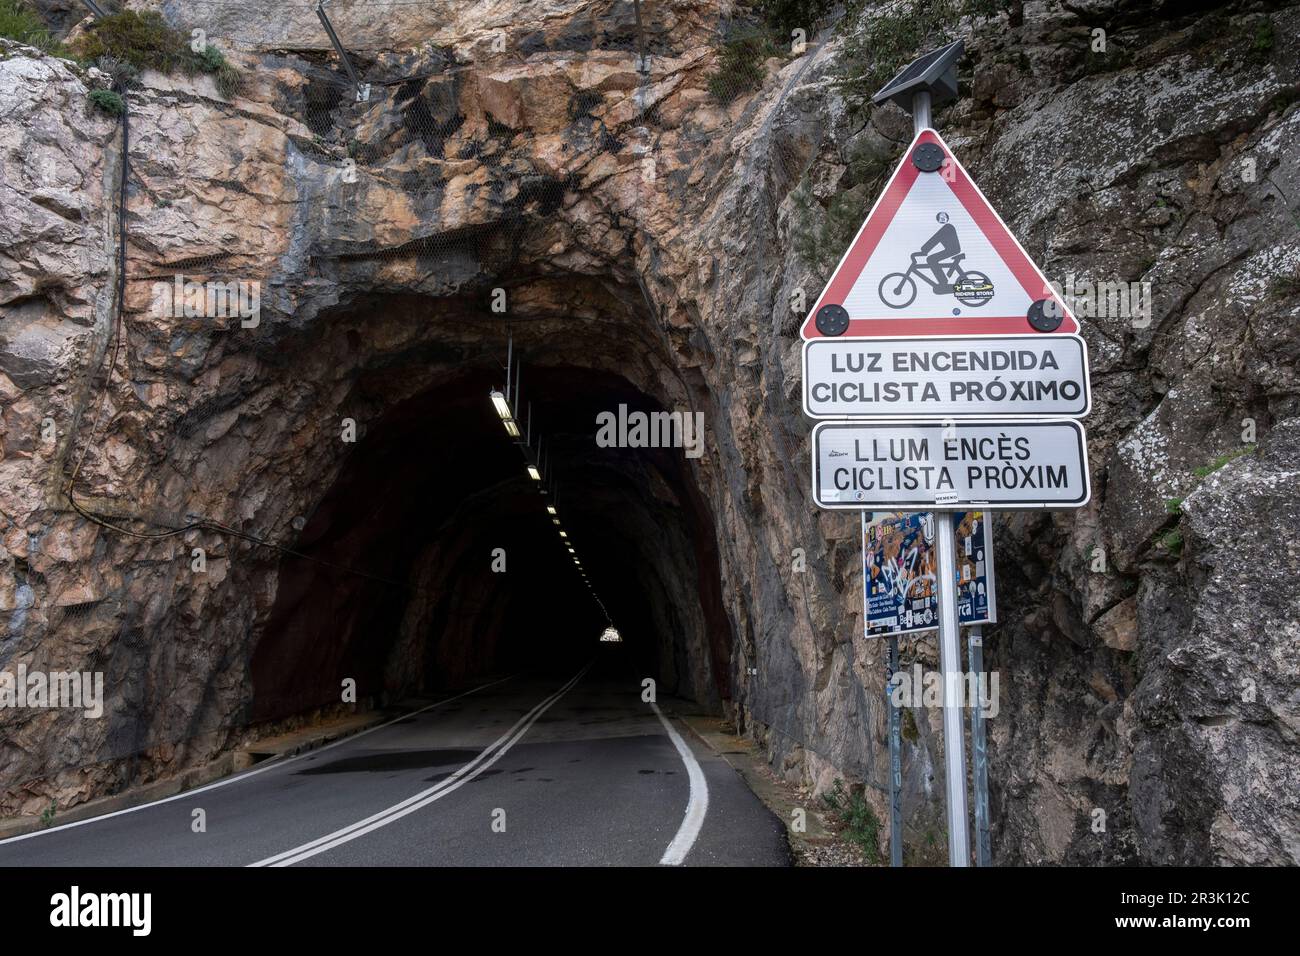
(0, 658, 789, 866)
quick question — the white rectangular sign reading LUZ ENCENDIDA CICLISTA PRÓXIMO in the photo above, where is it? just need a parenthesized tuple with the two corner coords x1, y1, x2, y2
(803, 334, 1091, 419)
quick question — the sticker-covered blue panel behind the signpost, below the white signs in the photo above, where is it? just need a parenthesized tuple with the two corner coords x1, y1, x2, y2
(862, 511, 997, 637)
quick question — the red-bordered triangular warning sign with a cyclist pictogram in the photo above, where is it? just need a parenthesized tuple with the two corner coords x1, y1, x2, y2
(801, 129, 1079, 338)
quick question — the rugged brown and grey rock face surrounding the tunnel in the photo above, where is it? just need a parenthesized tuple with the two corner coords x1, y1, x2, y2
(0, 0, 1300, 864)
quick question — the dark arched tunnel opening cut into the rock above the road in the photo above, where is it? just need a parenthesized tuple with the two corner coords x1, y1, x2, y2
(248, 283, 731, 722)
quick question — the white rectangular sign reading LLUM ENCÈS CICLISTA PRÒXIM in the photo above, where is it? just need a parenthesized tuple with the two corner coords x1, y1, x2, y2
(813, 419, 1091, 511)
